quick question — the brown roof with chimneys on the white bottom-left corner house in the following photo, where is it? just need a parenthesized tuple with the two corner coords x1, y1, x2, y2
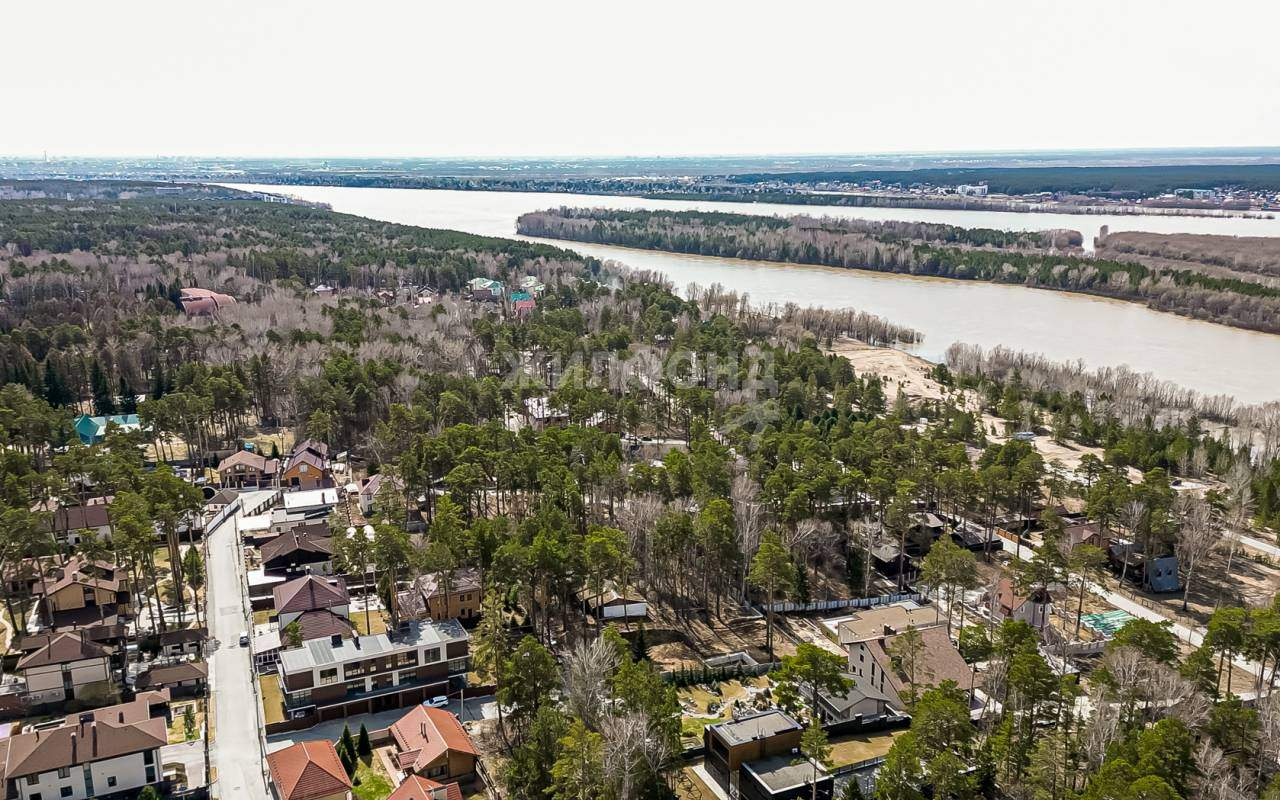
(0, 691, 169, 781)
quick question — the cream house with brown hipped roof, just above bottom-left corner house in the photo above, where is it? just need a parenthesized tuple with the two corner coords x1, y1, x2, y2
(18, 626, 116, 705)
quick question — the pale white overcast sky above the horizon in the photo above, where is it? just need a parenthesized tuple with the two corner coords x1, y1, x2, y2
(10, 0, 1280, 157)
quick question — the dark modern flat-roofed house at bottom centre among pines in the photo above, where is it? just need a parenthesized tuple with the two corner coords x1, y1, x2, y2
(703, 709, 832, 800)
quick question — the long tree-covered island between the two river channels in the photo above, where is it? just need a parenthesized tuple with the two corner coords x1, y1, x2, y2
(517, 209, 1280, 333)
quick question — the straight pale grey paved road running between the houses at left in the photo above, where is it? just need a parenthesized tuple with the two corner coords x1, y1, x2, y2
(207, 499, 270, 800)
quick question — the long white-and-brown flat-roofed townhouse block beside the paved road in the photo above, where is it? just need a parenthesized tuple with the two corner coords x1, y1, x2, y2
(279, 620, 470, 722)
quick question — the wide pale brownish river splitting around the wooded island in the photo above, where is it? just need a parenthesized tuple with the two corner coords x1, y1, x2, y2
(228, 184, 1280, 403)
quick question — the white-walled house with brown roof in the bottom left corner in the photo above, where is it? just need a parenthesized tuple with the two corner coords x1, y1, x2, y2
(0, 691, 169, 800)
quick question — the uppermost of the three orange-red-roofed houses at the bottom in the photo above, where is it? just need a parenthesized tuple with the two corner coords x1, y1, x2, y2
(390, 705, 479, 782)
